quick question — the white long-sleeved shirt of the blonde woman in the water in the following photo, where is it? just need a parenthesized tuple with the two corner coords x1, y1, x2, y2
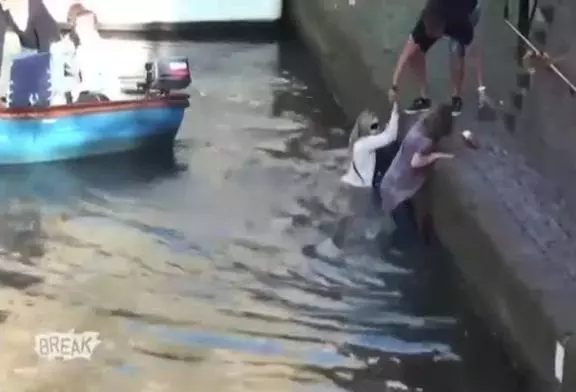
(341, 105, 400, 188)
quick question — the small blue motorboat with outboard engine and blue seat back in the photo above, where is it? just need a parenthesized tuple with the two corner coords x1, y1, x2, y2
(0, 53, 191, 165)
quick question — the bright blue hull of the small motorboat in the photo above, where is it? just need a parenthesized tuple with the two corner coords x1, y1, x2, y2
(0, 106, 185, 165)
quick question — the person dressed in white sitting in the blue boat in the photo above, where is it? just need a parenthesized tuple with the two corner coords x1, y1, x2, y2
(65, 4, 121, 101)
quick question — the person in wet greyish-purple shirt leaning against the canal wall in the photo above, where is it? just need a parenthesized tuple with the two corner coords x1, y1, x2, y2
(380, 104, 454, 216)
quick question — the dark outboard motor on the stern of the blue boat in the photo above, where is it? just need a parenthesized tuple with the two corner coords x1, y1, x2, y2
(138, 57, 192, 94)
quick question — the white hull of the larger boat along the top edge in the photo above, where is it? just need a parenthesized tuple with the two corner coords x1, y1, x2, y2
(44, 0, 282, 30)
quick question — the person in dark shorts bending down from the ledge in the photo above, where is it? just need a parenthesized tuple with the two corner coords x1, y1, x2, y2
(389, 0, 485, 116)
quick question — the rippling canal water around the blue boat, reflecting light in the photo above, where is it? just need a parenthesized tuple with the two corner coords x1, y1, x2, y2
(0, 35, 516, 392)
